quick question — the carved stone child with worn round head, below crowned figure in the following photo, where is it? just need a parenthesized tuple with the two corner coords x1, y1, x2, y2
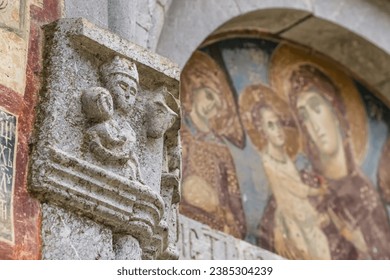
(81, 87, 141, 180)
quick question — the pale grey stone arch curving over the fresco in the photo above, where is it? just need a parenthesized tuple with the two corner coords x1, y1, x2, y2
(157, 0, 390, 104)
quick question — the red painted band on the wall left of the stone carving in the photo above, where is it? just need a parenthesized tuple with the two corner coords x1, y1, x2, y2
(0, 0, 61, 259)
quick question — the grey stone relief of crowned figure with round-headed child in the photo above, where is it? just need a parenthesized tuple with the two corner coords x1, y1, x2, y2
(81, 56, 142, 181)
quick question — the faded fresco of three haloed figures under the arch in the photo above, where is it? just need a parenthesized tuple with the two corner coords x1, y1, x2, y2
(180, 38, 390, 259)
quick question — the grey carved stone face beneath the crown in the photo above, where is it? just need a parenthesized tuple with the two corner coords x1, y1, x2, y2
(106, 74, 138, 112)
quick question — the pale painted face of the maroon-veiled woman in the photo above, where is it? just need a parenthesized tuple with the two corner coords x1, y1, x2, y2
(297, 91, 340, 156)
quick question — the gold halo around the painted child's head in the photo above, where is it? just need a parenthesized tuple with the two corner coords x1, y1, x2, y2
(239, 84, 301, 158)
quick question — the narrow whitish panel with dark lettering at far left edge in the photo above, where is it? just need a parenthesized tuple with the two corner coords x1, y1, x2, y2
(0, 110, 16, 243)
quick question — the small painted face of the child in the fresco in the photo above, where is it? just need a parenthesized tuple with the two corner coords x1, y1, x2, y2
(261, 108, 286, 147)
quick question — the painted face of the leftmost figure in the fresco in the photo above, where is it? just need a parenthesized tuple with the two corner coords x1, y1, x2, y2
(193, 87, 222, 120)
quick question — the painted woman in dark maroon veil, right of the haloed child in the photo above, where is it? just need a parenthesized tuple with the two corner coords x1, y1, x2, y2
(289, 64, 390, 259)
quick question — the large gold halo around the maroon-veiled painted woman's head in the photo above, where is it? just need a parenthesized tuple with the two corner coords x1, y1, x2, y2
(269, 44, 368, 163)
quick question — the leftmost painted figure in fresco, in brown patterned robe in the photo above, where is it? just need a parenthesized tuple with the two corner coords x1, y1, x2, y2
(180, 50, 246, 238)
